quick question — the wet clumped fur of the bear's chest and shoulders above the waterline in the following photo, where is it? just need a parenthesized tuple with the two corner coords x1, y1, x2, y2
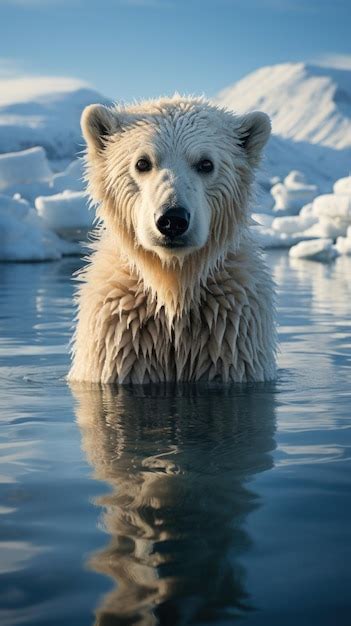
(70, 246, 274, 384)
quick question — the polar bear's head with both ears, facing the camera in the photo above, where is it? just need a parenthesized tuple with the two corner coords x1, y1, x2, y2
(82, 96, 270, 263)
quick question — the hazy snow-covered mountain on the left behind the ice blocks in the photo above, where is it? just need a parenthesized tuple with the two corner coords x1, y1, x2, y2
(0, 77, 109, 160)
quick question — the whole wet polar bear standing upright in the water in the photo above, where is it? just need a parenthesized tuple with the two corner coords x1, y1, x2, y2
(69, 95, 276, 384)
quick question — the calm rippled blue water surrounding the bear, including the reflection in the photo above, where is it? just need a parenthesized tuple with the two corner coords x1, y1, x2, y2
(0, 253, 351, 626)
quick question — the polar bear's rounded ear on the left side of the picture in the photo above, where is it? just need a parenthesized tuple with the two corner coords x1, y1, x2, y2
(80, 104, 119, 152)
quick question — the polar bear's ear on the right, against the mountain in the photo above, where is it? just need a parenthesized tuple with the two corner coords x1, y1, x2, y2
(239, 111, 272, 165)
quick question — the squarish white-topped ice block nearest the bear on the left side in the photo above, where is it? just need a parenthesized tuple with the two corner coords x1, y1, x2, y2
(35, 191, 94, 234)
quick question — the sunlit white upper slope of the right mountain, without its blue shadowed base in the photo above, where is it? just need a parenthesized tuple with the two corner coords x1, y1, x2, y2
(218, 63, 351, 149)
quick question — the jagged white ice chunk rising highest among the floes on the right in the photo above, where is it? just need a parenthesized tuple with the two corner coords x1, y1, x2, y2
(271, 170, 318, 215)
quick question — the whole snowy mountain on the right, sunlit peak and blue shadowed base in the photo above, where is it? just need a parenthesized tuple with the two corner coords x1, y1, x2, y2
(216, 63, 351, 191)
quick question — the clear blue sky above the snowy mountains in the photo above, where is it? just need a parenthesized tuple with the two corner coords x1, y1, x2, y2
(0, 0, 351, 100)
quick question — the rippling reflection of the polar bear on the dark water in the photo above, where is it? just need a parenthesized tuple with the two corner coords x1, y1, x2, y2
(72, 384, 275, 626)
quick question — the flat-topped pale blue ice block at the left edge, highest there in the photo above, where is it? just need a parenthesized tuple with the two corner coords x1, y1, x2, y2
(0, 146, 52, 191)
